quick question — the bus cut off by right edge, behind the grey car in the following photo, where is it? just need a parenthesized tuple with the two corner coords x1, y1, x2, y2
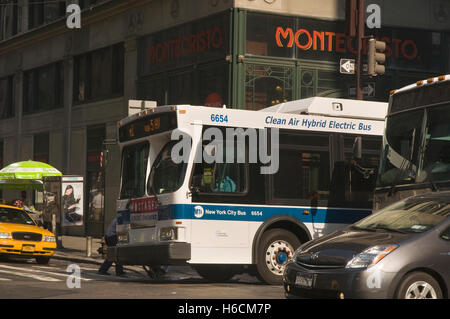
(374, 75, 450, 210)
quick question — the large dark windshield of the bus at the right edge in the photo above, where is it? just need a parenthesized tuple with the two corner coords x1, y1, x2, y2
(378, 103, 450, 186)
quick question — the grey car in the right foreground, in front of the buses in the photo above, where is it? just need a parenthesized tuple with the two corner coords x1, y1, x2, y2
(283, 191, 450, 299)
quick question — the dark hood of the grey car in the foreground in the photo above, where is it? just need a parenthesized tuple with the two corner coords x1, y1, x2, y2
(297, 229, 412, 267)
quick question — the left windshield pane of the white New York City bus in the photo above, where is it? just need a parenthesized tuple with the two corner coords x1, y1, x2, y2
(120, 142, 149, 199)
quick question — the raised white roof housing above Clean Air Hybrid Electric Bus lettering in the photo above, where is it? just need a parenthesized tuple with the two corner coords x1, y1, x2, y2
(260, 97, 388, 120)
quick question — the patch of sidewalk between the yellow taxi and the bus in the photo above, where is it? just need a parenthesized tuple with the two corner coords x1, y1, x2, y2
(52, 236, 104, 265)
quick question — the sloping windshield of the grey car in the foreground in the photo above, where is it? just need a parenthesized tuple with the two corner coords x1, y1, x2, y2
(354, 198, 450, 233)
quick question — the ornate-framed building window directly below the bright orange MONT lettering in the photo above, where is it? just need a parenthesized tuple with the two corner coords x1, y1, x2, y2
(245, 64, 294, 110)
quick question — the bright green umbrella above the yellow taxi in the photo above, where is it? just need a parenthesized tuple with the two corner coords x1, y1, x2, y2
(0, 161, 62, 190)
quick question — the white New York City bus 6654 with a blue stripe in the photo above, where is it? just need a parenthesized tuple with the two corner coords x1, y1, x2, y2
(107, 97, 387, 284)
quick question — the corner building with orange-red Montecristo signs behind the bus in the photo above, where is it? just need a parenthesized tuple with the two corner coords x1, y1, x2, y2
(0, 0, 450, 236)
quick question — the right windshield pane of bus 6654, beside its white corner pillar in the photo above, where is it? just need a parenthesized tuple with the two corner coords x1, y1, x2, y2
(148, 141, 187, 195)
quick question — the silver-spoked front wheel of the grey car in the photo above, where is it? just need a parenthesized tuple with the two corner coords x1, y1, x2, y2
(397, 272, 442, 299)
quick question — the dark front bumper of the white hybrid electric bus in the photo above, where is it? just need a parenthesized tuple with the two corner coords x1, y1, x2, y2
(106, 242, 191, 266)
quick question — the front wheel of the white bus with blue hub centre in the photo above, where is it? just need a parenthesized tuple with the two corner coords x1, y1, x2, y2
(256, 229, 300, 285)
